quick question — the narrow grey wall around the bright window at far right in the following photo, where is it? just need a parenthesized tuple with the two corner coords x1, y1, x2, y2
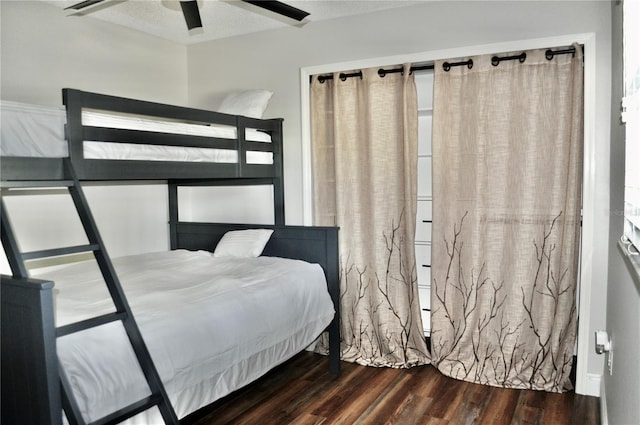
(603, 3, 640, 424)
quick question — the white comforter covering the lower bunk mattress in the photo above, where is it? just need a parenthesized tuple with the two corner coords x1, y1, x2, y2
(33, 250, 334, 424)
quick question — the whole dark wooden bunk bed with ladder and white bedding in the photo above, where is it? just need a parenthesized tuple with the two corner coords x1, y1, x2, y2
(0, 89, 340, 424)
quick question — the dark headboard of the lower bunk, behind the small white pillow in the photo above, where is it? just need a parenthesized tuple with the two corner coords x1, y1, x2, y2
(171, 222, 340, 373)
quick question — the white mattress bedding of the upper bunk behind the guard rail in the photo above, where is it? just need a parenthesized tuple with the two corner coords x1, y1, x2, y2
(0, 101, 273, 164)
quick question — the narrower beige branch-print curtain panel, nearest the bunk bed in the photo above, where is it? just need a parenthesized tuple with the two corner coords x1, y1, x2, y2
(311, 67, 427, 367)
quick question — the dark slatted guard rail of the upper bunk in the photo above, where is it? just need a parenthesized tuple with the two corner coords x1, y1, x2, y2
(62, 89, 282, 180)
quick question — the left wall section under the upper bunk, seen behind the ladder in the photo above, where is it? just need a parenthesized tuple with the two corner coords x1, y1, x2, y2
(1, 182, 169, 260)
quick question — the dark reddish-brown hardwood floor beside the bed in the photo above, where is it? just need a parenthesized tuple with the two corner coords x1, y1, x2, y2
(182, 352, 600, 425)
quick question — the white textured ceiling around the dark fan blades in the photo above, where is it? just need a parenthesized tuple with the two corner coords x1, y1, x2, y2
(45, 0, 424, 45)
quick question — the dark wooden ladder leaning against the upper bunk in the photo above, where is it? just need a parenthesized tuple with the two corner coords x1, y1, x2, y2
(0, 159, 179, 425)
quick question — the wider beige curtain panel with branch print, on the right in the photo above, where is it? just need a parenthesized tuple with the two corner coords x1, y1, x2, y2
(431, 46, 583, 392)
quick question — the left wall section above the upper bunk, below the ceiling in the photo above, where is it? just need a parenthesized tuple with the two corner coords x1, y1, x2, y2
(0, 1, 187, 106)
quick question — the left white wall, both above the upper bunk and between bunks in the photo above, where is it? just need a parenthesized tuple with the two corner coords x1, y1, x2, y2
(0, 1, 187, 273)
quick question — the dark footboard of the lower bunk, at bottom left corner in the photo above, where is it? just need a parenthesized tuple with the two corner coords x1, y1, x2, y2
(0, 275, 62, 425)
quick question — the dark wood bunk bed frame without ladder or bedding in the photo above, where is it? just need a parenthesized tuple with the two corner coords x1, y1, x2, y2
(0, 89, 340, 424)
